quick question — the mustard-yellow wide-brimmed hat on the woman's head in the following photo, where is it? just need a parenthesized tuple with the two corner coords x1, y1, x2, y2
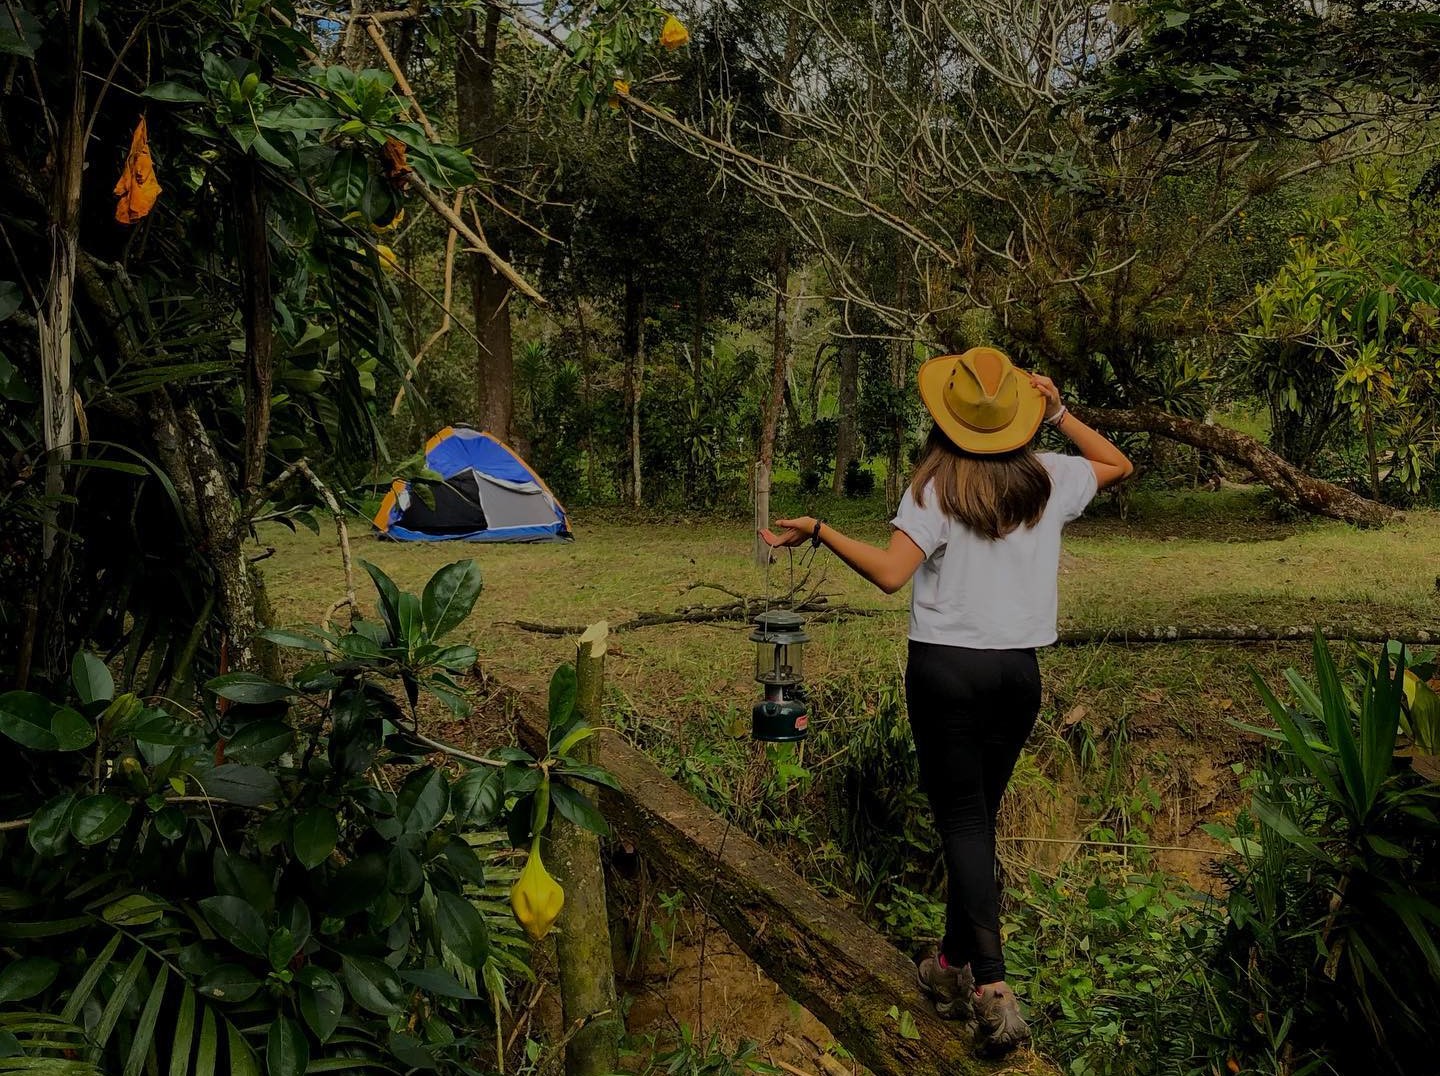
(919, 347, 1045, 455)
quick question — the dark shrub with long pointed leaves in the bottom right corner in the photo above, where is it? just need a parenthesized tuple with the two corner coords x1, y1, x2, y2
(1215, 638, 1440, 1073)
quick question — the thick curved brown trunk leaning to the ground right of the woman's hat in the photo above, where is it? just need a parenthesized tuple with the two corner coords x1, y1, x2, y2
(1071, 405, 1395, 527)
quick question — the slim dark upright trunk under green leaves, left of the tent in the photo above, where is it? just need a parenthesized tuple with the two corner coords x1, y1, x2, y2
(235, 161, 275, 496)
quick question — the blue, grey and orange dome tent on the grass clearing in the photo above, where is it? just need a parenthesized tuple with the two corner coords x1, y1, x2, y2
(374, 426, 572, 542)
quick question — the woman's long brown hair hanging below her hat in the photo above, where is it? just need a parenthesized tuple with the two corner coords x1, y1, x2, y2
(910, 426, 1050, 542)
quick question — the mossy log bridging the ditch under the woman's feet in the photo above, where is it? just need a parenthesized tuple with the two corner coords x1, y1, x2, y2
(510, 694, 1058, 1076)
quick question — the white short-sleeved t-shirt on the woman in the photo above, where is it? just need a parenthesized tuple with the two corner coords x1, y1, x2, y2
(891, 452, 1096, 650)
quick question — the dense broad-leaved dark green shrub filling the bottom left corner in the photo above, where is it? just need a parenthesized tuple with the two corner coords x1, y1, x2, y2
(0, 562, 609, 1076)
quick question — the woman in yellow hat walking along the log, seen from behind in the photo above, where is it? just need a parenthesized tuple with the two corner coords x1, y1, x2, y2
(762, 347, 1133, 1057)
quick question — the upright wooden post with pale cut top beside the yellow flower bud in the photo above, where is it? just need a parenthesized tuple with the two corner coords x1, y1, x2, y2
(550, 621, 621, 1076)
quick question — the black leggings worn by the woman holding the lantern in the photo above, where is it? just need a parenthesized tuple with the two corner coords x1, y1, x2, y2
(904, 640, 1040, 985)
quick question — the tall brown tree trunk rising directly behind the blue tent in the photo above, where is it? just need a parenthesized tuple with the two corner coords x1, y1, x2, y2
(455, 7, 516, 441)
